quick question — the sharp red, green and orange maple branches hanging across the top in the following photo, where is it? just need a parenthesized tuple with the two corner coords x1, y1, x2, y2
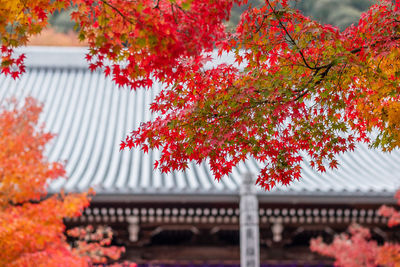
(0, 0, 400, 190)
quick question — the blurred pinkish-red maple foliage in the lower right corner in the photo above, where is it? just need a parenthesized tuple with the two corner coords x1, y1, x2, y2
(310, 191, 400, 267)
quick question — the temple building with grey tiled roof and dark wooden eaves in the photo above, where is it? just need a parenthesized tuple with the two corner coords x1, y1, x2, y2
(0, 47, 400, 267)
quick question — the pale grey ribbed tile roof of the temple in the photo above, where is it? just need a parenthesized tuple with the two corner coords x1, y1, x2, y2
(0, 48, 400, 202)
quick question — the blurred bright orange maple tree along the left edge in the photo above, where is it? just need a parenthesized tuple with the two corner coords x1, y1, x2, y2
(0, 98, 129, 266)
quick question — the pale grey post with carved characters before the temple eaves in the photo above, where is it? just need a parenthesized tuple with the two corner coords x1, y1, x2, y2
(240, 174, 260, 267)
